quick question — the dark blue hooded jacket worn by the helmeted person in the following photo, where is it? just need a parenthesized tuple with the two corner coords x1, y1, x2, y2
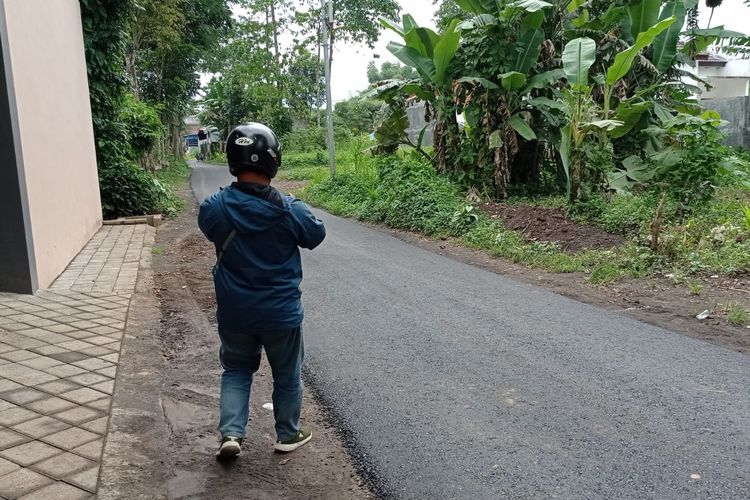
(198, 186, 326, 334)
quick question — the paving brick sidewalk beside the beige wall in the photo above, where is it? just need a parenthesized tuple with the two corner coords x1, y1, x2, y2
(0, 225, 154, 499)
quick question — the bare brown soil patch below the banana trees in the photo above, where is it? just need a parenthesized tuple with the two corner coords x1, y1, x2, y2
(479, 203, 625, 253)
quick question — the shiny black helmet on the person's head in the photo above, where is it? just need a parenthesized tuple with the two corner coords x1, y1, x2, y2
(227, 123, 281, 179)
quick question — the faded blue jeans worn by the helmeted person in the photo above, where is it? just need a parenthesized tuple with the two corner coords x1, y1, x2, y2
(219, 327, 305, 441)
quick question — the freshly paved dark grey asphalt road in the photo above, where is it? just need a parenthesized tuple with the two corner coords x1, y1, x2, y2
(193, 162, 750, 500)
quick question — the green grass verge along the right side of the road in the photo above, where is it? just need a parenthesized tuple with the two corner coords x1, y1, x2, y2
(280, 144, 750, 284)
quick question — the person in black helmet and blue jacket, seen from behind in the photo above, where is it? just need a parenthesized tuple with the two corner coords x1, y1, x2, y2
(198, 123, 325, 457)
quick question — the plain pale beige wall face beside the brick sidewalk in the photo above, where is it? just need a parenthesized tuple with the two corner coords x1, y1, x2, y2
(0, 0, 102, 288)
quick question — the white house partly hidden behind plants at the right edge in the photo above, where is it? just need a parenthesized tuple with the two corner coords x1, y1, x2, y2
(694, 53, 750, 101)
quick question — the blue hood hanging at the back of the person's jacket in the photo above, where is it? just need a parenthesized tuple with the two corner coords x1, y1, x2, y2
(221, 186, 292, 233)
